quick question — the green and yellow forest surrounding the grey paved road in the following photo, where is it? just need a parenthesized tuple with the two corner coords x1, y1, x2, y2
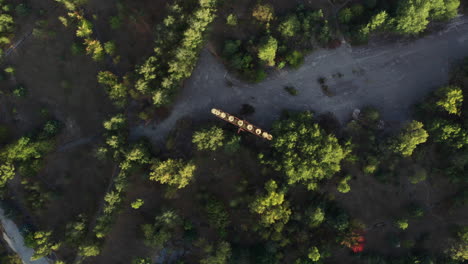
(0, 0, 468, 264)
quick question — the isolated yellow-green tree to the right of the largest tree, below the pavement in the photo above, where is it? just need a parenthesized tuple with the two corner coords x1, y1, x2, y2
(390, 120, 429, 157)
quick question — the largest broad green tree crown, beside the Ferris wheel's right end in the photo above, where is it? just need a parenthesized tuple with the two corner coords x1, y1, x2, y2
(260, 112, 348, 190)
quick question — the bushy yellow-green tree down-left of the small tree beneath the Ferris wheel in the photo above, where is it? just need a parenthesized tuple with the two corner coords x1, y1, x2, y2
(150, 159, 196, 189)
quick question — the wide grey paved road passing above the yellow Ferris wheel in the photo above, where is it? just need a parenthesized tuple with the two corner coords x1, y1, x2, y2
(132, 16, 468, 144)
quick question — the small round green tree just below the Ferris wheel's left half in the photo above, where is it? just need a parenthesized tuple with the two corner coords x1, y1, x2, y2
(192, 126, 225, 151)
